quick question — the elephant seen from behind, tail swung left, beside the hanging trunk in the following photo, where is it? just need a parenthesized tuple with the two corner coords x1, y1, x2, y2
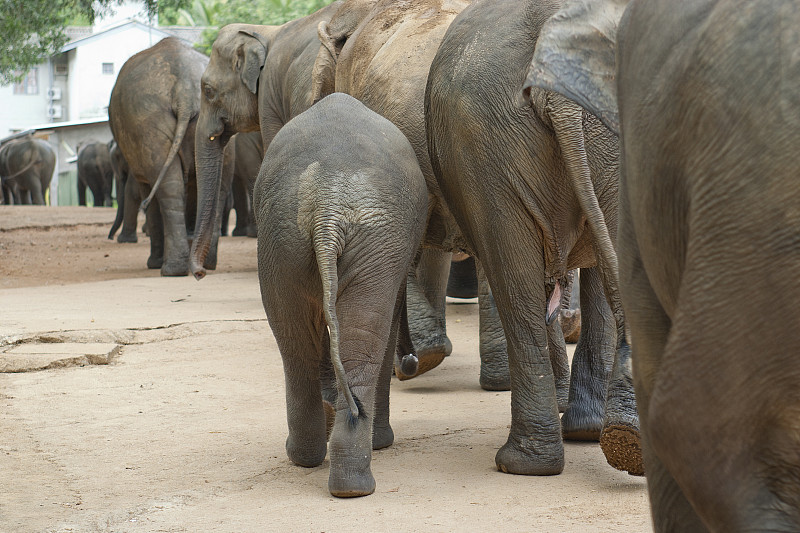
(108, 38, 227, 276)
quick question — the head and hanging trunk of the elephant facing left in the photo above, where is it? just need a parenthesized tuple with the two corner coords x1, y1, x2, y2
(191, 24, 275, 279)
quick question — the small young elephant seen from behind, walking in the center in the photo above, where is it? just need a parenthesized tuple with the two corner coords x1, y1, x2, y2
(254, 93, 428, 497)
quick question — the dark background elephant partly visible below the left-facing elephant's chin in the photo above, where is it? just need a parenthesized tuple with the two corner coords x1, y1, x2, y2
(222, 131, 264, 237)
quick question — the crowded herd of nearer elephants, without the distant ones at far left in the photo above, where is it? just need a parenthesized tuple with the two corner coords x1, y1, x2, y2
(97, 0, 800, 531)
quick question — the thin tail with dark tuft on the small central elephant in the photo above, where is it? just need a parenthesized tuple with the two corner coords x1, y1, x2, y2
(313, 224, 361, 424)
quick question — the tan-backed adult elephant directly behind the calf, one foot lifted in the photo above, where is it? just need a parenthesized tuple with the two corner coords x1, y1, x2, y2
(313, 0, 536, 388)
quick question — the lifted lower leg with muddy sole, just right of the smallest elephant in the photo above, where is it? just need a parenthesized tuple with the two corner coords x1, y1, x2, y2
(395, 248, 453, 380)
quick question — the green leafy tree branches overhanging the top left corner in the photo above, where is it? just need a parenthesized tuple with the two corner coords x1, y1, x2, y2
(0, 0, 191, 85)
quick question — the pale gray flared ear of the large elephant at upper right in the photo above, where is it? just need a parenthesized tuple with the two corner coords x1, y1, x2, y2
(523, 0, 630, 134)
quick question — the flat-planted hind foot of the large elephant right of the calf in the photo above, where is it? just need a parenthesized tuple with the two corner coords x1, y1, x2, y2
(494, 435, 564, 476)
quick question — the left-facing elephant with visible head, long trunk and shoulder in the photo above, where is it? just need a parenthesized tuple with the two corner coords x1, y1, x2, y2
(191, 2, 340, 279)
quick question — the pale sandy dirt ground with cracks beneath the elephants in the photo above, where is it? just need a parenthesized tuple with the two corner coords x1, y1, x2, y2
(0, 206, 651, 532)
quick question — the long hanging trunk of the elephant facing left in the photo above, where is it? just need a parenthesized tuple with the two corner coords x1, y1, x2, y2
(189, 129, 229, 279)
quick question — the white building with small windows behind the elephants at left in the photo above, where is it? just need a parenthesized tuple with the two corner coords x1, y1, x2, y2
(0, 2, 203, 205)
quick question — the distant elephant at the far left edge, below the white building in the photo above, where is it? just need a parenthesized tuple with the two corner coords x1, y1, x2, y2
(0, 137, 56, 205)
